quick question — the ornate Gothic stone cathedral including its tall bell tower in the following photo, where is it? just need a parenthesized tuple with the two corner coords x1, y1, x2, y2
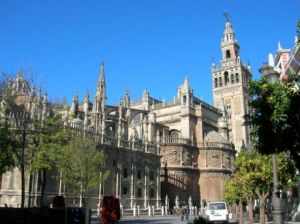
(0, 21, 251, 209)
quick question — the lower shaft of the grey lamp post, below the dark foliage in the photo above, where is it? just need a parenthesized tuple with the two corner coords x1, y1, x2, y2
(272, 153, 283, 224)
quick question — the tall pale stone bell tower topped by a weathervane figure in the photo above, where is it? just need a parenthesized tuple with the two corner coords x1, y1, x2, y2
(212, 14, 252, 152)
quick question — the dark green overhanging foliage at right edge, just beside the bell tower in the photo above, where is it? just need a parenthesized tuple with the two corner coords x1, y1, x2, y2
(245, 76, 300, 169)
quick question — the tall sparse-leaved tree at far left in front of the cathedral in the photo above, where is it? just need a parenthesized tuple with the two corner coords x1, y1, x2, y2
(0, 72, 42, 208)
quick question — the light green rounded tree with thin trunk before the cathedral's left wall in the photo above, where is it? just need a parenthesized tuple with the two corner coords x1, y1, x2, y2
(60, 136, 109, 206)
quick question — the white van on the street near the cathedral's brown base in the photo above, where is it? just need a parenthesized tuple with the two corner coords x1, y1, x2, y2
(205, 201, 229, 223)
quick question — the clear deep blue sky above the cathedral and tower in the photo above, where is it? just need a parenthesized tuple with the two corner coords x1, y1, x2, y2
(0, 0, 300, 104)
